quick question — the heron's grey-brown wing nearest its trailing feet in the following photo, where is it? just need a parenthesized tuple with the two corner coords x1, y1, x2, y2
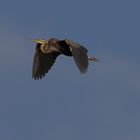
(65, 39, 88, 73)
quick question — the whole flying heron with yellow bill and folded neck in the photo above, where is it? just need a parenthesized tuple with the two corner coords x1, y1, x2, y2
(32, 38, 98, 80)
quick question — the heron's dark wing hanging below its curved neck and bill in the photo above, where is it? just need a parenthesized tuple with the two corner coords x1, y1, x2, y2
(32, 49, 60, 80)
